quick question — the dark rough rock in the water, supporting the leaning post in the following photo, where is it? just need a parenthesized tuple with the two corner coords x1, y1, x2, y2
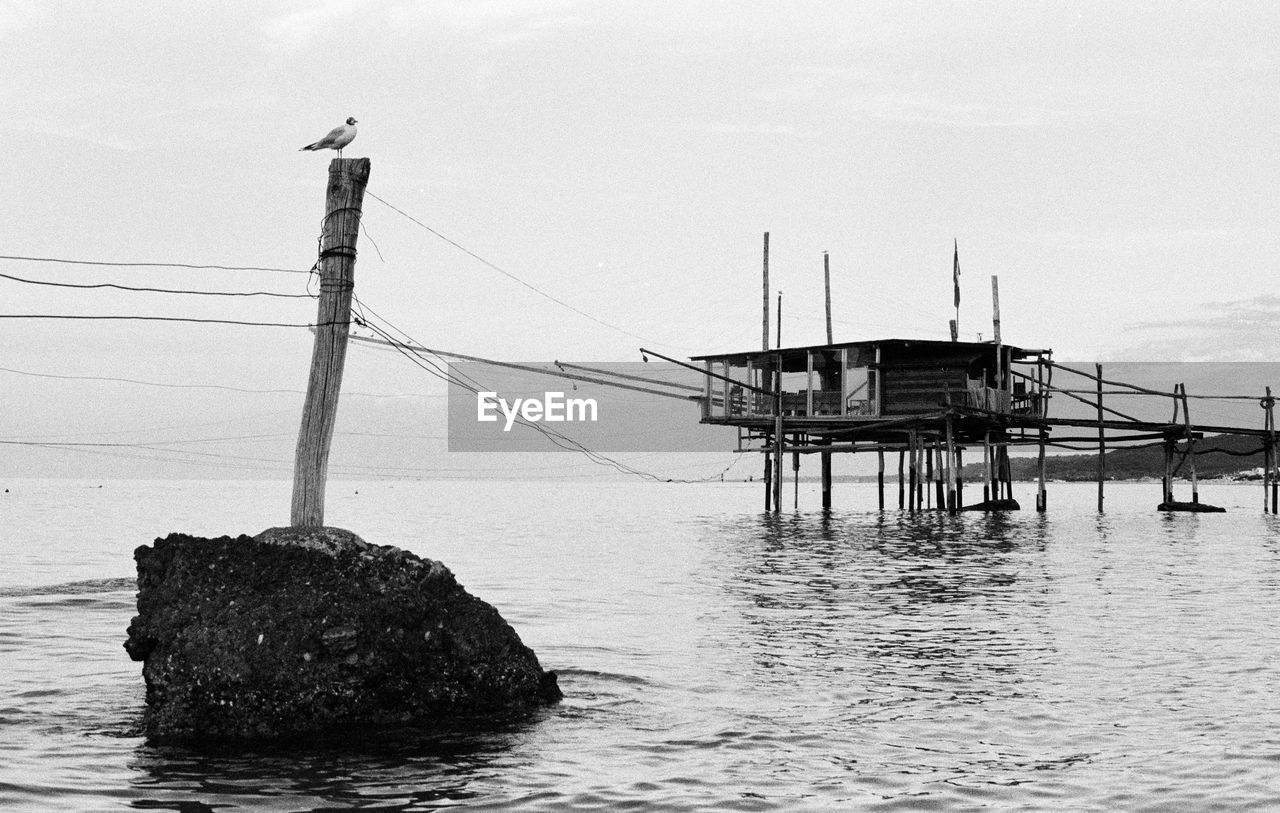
(124, 527, 562, 739)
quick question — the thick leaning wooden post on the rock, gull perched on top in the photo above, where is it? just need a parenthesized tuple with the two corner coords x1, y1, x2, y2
(289, 157, 369, 527)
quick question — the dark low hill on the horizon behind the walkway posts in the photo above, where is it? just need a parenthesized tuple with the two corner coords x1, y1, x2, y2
(964, 435, 1262, 481)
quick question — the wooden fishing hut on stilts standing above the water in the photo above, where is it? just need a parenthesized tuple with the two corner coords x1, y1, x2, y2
(692, 339, 1050, 511)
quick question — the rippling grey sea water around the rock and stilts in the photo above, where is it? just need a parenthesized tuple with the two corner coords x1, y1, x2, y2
(0, 479, 1280, 813)
